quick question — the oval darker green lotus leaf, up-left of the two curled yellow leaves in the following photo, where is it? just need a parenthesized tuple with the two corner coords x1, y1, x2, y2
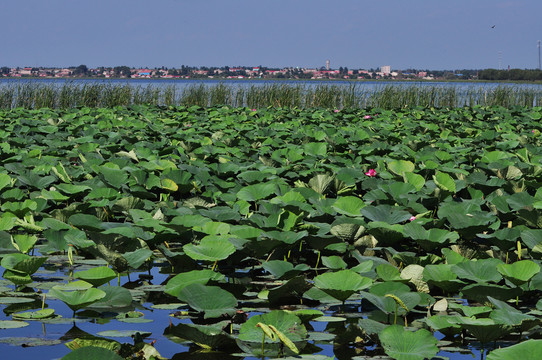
(177, 283, 237, 318)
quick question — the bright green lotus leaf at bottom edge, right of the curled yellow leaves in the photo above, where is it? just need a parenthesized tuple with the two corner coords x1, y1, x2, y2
(378, 325, 439, 360)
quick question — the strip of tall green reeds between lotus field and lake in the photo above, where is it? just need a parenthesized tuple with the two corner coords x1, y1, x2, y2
(0, 81, 542, 109)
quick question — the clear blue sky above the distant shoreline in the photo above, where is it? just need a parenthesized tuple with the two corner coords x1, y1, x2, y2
(4, 0, 542, 70)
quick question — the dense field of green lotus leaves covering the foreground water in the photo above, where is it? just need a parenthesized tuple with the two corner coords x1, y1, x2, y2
(0, 102, 542, 359)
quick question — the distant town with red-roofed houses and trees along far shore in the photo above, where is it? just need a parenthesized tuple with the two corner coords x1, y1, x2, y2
(0, 64, 484, 80)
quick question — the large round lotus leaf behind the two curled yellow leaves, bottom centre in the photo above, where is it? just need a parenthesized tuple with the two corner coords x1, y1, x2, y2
(236, 310, 307, 357)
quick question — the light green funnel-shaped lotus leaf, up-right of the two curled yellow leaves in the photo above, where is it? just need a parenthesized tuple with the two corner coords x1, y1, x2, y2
(314, 270, 373, 302)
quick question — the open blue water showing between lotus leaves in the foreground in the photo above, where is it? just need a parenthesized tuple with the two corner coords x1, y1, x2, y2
(0, 266, 490, 360)
